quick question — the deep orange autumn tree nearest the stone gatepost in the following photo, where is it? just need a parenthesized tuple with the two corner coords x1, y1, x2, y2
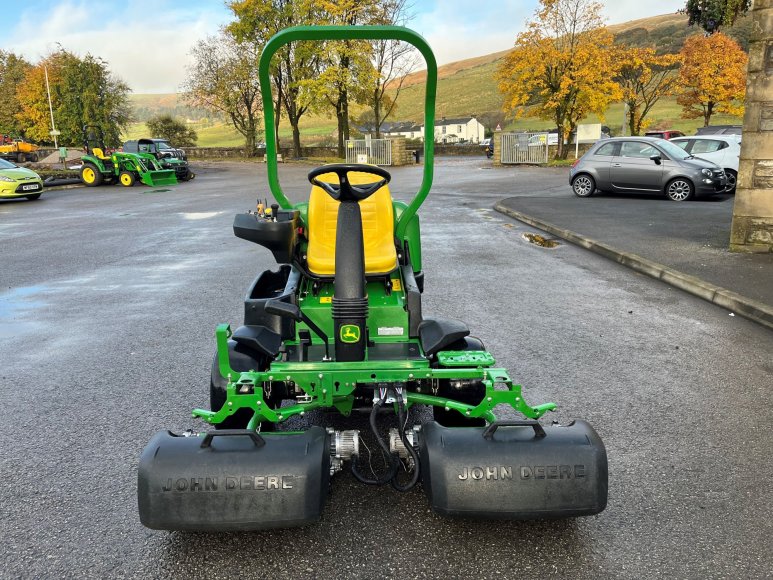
(676, 33, 748, 126)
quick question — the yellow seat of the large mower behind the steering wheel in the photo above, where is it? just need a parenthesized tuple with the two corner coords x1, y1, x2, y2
(306, 172, 397, 276)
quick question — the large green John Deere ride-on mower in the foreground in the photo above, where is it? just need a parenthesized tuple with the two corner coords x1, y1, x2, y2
(138, 26, 607, 531)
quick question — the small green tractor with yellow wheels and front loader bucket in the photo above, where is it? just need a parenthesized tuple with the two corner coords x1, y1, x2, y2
(81, 125, 177, 187)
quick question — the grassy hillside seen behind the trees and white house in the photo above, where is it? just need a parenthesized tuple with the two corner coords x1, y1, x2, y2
(127, 14, 751, 147)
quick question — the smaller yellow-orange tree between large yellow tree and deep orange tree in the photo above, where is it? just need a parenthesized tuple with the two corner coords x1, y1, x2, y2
(615, 47, 681, 135)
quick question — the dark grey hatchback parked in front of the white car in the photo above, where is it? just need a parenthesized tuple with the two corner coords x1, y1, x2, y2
(569, 137, 727, 201)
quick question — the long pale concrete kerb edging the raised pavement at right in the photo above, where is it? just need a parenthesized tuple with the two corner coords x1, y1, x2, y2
(494, 203, 773, 329)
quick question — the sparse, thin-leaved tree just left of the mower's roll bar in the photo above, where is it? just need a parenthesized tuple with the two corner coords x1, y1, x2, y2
(183, 30, 261, 157)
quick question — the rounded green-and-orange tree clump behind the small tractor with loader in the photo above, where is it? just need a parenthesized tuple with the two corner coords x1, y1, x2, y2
(16, 48, 132, 146)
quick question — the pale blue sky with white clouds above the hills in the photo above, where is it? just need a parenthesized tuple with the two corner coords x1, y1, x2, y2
(0, 0, 685, 93)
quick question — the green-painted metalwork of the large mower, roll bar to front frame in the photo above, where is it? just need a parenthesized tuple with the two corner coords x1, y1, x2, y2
(192, 26, 556, 429)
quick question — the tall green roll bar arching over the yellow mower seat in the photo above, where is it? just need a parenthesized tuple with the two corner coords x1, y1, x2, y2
(258, 26, 437, 240)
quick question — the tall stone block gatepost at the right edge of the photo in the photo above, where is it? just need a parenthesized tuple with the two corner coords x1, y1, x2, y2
(730, 0, 773, 252)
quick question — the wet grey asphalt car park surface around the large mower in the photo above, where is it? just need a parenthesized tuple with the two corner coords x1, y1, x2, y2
(0, 158, 773, 578)
